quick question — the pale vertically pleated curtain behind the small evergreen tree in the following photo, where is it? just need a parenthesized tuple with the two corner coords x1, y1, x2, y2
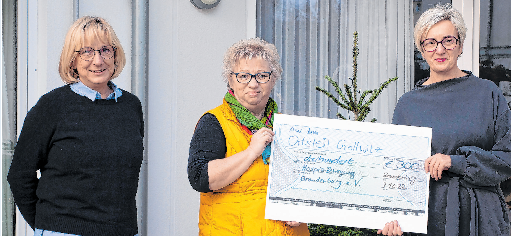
(256, 0, 413, 123)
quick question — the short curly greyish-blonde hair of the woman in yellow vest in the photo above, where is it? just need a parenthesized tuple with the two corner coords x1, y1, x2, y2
(222, 38, 282, 86)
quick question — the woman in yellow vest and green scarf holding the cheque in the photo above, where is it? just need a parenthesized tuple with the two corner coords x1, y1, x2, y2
(188, 38, 309, 236)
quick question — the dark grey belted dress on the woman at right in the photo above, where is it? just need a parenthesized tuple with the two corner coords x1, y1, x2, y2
(393, 71, 511, 236)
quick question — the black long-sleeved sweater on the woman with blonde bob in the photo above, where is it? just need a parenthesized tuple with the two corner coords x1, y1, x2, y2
(8, 85, 144, 236)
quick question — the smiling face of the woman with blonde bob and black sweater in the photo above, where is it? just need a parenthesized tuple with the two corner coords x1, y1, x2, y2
(73, 34, 115, 94)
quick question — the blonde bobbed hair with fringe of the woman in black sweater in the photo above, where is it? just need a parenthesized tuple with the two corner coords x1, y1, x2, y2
(59, 16, 126, 84)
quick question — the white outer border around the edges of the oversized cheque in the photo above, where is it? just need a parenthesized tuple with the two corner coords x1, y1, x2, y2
(265, 114, 431, 233)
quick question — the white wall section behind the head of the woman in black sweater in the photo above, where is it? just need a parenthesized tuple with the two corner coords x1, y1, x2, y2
(18, 0, 131, 109)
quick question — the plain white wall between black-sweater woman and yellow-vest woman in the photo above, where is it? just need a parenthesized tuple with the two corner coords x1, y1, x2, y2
(147, 0, 247, 235)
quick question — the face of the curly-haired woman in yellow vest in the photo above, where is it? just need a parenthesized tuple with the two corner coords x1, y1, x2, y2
(229, 58, 275, 118)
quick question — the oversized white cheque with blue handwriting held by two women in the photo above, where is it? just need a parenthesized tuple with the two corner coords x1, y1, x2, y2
(266, 114, 431, 233)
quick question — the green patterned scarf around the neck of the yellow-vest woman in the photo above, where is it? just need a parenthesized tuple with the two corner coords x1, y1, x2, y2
(224, 90, 278, 164)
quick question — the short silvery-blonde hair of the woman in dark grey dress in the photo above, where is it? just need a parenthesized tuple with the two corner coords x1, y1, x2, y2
(413, 3, 467, 52)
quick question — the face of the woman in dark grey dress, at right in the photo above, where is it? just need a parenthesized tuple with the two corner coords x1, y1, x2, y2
(421, 20, 463, 78)
